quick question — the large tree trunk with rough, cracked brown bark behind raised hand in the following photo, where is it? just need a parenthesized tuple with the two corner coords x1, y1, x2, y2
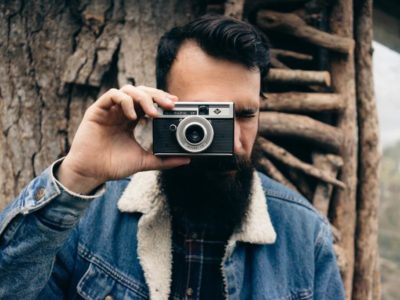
(0, 0, 200, 209)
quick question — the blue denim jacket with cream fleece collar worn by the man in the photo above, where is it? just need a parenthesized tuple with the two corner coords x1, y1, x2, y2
(0, 162, 344, 300)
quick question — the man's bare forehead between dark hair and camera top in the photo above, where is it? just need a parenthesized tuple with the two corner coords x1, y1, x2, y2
(167, 42, 260, 107)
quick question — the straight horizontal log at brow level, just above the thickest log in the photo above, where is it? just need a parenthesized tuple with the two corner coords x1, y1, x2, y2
(260, 92, 346, 112)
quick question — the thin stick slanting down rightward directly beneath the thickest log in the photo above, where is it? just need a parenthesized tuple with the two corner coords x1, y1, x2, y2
(257, 137, 346, 188)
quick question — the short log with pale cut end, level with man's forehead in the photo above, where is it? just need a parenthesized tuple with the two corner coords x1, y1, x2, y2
(264, 68, 331, 86)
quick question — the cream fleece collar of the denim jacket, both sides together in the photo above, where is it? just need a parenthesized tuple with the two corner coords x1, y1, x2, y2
(118, 171, 276, 300)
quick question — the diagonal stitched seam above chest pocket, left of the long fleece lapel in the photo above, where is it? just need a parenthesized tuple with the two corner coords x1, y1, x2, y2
(77, 242, 148, 297)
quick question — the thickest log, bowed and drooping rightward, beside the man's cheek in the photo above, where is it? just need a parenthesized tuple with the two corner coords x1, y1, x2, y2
(259, 112, 344, 153)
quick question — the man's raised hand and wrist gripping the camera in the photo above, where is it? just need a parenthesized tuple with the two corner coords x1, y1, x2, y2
(57, 85, 190, 194)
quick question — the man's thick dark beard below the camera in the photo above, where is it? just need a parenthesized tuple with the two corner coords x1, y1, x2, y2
(159, 156, 254, 235)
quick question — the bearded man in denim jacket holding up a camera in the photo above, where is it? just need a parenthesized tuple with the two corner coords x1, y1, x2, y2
(0, 16, 344, 300)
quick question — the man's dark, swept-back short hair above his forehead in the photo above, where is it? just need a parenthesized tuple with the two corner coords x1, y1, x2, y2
(156, 15, 270, 92)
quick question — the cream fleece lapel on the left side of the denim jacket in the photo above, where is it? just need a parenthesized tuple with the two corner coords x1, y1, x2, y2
(118, 171, 172, 300)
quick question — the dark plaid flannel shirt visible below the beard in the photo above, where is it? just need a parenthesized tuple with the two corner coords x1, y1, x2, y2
(170, 218, 229, 300)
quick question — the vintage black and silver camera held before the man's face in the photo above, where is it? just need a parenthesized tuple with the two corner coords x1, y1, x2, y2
(153, 102, 234, 156)
